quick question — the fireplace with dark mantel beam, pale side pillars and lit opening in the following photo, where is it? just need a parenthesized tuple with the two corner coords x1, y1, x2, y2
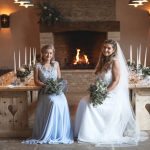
(40, 21, 120, 69)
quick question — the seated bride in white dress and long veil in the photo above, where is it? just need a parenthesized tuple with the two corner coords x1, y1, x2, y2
(74, 40, 148, 146)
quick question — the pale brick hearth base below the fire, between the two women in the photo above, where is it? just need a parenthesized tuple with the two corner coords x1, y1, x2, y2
(61, 70, 95, 122)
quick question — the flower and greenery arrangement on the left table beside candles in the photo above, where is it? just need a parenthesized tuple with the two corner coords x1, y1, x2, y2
(16, 65, 31, 78)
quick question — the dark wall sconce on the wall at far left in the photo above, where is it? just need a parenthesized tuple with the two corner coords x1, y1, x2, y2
(0, 14, 9, 28)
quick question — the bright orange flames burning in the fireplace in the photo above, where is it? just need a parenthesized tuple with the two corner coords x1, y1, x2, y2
(73, 49, 89, 65)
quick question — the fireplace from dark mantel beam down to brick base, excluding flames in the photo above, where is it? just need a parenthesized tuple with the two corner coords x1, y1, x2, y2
(40, 21, 120, 121)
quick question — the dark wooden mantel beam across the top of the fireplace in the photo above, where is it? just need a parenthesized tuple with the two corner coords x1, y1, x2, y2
(40, 21, 120, 33)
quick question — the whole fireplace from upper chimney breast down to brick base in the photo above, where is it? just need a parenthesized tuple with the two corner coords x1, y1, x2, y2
(40, 0, 120, 120)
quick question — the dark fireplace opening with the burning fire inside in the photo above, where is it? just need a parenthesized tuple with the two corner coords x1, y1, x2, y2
(54, 31, 107, 69)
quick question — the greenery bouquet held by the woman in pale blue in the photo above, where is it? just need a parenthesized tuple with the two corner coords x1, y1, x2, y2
(44, 78, 67, 95)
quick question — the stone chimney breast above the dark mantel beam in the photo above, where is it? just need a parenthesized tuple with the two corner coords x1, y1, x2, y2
(49, 0, 116, 21)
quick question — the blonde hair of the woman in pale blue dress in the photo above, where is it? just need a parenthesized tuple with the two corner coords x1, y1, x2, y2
(41, 44, 55, 64)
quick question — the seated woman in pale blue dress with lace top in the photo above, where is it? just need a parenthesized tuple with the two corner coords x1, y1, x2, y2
(23, 45, 73, 144)
